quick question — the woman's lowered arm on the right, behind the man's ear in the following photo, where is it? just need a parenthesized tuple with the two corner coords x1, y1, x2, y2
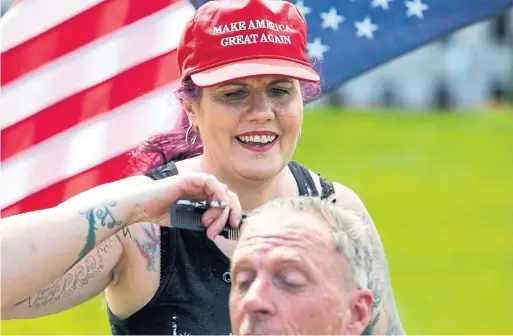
(334, 183, 405, 335)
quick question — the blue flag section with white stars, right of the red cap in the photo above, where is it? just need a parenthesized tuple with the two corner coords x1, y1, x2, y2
(291, 0, 513, 93)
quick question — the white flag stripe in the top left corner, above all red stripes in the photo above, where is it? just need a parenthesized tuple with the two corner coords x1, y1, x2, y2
(0, 0, 105, 52)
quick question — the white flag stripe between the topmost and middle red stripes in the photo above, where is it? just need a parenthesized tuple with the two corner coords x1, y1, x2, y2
(1, 2, 194, 129)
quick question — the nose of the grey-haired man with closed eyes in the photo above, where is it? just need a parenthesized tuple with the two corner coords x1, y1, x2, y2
(243, 279, 276, 318)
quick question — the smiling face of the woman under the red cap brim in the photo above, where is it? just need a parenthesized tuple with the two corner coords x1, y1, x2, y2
(190, 77, 303, 180)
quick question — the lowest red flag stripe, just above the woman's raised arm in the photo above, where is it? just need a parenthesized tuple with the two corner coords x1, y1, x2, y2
(1, 154, 130, 217)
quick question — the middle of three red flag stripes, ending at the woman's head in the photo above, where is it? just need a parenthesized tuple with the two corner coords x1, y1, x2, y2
(0, 49, 180, 161)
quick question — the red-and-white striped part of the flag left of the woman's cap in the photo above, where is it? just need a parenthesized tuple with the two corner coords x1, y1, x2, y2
(1, 0, 195, 216)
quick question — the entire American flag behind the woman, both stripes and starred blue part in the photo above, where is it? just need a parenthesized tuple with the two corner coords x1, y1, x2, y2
(0, 0, 513, 216)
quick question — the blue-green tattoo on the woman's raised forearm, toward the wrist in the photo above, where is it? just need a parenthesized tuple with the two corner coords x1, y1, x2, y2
(66, 201, 122, 272)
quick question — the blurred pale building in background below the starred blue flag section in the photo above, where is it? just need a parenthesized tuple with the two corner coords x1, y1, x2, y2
(319, 9, 513, 110)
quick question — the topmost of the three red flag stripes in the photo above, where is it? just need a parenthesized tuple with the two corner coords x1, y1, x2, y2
(0, 0, 179, 85)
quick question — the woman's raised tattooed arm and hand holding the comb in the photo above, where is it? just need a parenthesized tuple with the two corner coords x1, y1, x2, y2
(0, 173, 242, 319)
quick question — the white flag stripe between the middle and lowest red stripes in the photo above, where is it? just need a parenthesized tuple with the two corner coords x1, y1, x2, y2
(0, 83, 180, 208)
